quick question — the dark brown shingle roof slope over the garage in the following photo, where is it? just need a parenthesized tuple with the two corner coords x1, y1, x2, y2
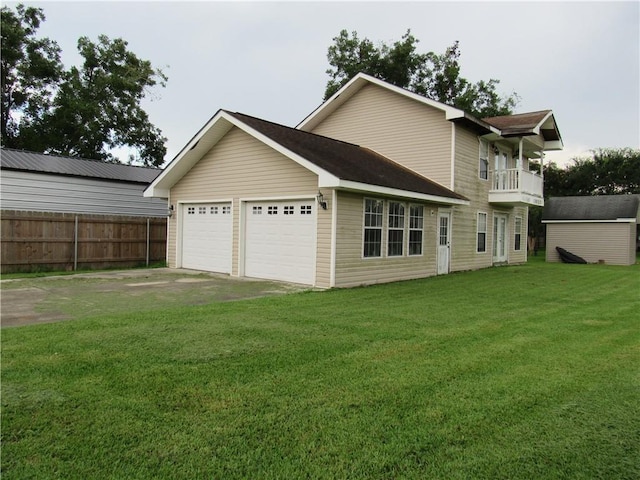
(227, 112, 467, 200)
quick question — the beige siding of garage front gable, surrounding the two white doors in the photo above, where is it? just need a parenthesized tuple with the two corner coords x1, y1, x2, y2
(168, 127, 330, 284)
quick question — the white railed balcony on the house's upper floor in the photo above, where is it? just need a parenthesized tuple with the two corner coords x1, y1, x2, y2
(489, 168, 544, 207)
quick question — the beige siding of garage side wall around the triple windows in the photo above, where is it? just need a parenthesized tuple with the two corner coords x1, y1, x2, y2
(332, 191, 437, 287)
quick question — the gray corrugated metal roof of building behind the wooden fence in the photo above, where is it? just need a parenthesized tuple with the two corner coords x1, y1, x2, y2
(0, 148, 162, 184)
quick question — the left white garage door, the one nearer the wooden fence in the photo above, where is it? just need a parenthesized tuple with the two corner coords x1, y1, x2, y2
(182, 203, 233, 273)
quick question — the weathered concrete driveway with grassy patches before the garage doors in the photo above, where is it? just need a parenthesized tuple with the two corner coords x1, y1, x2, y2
(0, 268, 311, 328)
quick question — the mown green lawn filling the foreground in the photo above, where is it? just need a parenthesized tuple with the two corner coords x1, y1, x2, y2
(2, 259, 640, 480)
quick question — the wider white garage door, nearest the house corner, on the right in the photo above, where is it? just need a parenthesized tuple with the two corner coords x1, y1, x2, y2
(245, 200, 316, 285)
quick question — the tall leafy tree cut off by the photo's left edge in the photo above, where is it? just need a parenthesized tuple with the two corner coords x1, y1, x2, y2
(0, 5, 63, 148)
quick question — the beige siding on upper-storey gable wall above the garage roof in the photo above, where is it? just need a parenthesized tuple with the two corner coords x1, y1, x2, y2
(306, 85, 451, 188)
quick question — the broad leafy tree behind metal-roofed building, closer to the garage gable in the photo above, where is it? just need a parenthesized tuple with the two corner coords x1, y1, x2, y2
(2, 3, 167, 166)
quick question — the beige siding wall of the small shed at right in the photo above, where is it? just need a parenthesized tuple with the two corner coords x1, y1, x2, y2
(546, 223, 636, 265)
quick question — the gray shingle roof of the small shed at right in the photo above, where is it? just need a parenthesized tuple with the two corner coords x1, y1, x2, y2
(542, 195, 640, 222)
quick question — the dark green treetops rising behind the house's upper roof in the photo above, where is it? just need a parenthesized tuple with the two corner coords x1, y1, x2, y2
(324, 30, 518, 118)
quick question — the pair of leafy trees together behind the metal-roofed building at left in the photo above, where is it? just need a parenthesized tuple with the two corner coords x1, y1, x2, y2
(0, 5, 167, 166)
